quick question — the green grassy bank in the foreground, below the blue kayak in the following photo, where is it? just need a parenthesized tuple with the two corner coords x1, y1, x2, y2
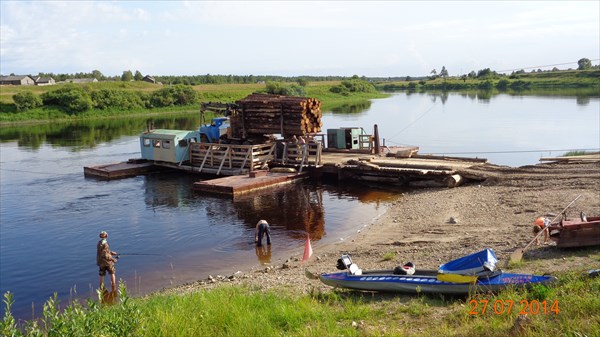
(0, 258, 600, 337)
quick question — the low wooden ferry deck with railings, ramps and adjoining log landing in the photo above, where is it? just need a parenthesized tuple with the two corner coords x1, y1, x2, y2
(84, 143, 487, 189)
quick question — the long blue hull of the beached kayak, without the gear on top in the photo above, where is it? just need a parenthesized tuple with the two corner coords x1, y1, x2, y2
(319, 270, 556, 295)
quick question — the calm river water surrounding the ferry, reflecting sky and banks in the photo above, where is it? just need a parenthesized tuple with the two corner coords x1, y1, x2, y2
(0, 89, 600, 319)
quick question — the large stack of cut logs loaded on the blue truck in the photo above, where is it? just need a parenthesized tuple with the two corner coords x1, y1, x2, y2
(231, 94, 323, 138)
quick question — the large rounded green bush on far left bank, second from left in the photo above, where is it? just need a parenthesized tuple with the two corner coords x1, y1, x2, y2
(42, 84, 92, 114)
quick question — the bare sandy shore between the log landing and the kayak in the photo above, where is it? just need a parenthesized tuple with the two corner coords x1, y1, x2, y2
(161, 163, 600, 293)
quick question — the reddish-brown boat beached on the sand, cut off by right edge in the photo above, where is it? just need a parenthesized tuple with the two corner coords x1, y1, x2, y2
(548, 213, 600, 248)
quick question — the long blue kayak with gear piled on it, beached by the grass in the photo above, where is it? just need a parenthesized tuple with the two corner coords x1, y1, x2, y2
(319, 249, 556, 295)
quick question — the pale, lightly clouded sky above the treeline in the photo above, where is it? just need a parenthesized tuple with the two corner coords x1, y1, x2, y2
(0, 0, 600, 77)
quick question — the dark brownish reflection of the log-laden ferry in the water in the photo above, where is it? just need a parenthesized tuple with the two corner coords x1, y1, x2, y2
(139, 172, 390, 242)
